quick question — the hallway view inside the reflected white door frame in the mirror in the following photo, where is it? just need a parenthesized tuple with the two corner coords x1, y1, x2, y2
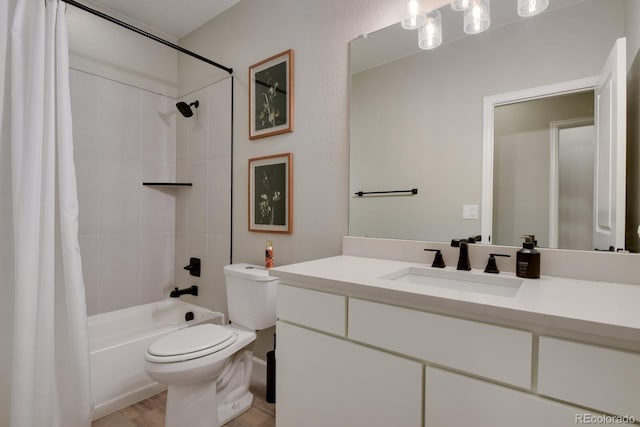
(492, 91, 593, 249)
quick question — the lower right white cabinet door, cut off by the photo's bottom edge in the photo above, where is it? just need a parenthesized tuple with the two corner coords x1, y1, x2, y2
(425, 366, 596, 427)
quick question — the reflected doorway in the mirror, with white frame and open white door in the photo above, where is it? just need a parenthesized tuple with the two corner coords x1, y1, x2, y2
(482, 39, 626, 250)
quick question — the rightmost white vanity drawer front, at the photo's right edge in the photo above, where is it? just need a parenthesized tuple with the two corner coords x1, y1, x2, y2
(538, 337, 640, 419)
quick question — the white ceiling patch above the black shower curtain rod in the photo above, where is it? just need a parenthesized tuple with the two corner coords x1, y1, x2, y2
(82, 0, 239, 40)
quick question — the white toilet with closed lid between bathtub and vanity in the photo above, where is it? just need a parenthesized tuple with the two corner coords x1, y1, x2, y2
(145, 264, 278, 427)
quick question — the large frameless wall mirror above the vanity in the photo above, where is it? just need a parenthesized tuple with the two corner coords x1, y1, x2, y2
(349, 0, 639, 252)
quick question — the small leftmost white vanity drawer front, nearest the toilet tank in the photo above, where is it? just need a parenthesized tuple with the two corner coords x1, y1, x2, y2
(277, 284, 346, 336)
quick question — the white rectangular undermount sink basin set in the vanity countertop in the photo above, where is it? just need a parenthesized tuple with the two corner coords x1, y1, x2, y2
(380, 267, 523, 297)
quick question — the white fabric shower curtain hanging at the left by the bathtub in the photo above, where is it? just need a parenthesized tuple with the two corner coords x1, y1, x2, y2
(0, 0, 92, 427)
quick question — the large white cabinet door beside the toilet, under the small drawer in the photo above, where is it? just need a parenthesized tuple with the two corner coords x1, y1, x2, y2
(276, 321, 422, 427)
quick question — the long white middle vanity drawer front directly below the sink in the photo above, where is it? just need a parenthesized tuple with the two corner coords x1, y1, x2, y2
(348, 298, 533, 389)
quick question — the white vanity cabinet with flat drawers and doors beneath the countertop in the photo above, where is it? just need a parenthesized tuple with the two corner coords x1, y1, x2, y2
(276, 258, 640, 427)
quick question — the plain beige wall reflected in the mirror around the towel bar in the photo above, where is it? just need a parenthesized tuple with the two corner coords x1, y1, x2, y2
(349, 0, 624, 241)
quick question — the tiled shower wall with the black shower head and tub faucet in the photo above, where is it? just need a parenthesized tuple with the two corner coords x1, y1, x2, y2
(175, 77, 234, 315)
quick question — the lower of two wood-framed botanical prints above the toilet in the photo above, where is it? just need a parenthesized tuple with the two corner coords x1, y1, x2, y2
(249, 153, 293, 234)
